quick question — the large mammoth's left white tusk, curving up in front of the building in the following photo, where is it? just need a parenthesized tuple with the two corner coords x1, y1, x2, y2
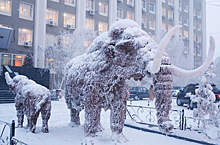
(147, 25, 182, 73)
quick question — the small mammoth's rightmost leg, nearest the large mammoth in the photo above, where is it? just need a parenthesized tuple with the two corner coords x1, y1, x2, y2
(41, 102, 51, 133)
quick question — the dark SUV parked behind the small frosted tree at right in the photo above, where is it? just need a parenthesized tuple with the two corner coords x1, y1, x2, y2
(176, 83, 220, 109)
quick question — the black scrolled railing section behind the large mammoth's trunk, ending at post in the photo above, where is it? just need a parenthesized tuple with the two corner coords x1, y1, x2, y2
(126, 105, 184, 130)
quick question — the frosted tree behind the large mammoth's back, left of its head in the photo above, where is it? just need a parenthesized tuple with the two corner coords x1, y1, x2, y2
(45, 29, 97, 89)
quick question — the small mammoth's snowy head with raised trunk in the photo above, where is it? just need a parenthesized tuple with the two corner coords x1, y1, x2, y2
(5, 72, 28, 93)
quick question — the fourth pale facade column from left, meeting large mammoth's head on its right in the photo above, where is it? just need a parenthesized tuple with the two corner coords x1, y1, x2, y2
(134, 0, 142, 26)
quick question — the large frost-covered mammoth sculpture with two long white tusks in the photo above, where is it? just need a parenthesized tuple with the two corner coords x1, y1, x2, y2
(65, 19, 214, 137)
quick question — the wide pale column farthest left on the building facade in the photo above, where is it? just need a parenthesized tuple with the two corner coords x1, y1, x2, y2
(34, 0, 47, 68)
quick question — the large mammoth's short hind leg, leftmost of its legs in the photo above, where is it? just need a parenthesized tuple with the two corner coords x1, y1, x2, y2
(70, 108, 80, 127)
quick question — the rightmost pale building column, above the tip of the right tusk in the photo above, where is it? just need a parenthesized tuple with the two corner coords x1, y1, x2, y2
(201, 0, 206, 62)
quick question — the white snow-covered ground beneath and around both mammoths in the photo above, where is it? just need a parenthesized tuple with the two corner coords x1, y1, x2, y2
(0, 99, 218, 145)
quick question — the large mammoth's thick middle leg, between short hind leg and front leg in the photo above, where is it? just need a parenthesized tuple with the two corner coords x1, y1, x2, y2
(84, 102, 102, 137)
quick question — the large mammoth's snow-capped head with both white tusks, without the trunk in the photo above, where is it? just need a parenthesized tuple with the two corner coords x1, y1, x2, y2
(104, 19, 215, 78)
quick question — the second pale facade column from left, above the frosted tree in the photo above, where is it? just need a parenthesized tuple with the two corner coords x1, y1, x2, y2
(76, 0, 86, 29)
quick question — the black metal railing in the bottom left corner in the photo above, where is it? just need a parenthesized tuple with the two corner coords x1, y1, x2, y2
(0, 120, 15, 145)
